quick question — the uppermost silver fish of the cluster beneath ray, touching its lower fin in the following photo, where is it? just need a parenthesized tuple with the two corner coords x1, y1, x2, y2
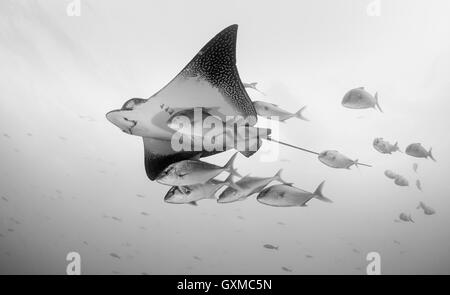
(156, 153, 240, 186)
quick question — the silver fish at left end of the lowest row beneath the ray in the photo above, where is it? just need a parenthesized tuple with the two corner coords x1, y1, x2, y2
(164, 174, 239, 204)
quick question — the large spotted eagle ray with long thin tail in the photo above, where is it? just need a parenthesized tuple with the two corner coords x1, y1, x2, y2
(106, 25, 370, 180)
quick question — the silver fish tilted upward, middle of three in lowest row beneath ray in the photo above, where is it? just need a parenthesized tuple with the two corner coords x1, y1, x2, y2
(217, 169, 288, 203)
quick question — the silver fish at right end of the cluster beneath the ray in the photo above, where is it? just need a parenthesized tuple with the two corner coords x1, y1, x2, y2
(256, 181, 332, 207)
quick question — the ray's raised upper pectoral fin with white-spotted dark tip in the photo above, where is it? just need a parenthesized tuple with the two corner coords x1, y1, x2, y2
(152, 25, 257, 125)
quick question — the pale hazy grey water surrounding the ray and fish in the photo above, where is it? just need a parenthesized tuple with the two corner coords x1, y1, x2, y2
(0, 0, 450, 275)
